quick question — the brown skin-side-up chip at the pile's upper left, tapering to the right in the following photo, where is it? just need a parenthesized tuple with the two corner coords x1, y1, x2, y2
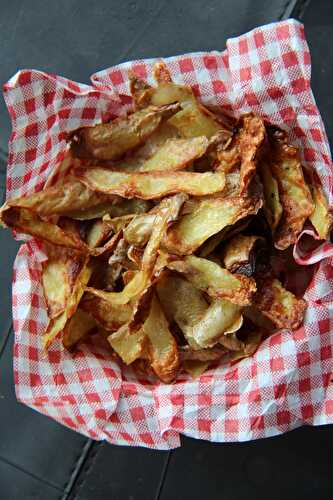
(71, 104, 180, 160)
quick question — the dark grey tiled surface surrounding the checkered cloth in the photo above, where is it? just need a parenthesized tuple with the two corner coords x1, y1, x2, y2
(0, 0, 333, 500)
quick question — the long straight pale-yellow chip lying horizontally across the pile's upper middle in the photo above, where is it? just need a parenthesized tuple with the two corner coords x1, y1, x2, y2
(74, 167, 225, 200)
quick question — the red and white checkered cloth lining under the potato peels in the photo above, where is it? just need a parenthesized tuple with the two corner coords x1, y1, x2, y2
(4, 20, 333, 449)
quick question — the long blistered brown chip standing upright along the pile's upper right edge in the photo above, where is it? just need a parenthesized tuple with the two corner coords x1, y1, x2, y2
(269, 127, 314, 250)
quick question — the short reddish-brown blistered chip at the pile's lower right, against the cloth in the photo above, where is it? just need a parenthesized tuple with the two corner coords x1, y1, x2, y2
(255, 278, 307, 330)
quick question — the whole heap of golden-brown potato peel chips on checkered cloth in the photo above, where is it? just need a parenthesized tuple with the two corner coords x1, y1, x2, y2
(0, 62, 332, 383)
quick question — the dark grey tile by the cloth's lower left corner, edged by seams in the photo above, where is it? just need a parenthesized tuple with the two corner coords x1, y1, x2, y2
(0, 333, 87, 490)
